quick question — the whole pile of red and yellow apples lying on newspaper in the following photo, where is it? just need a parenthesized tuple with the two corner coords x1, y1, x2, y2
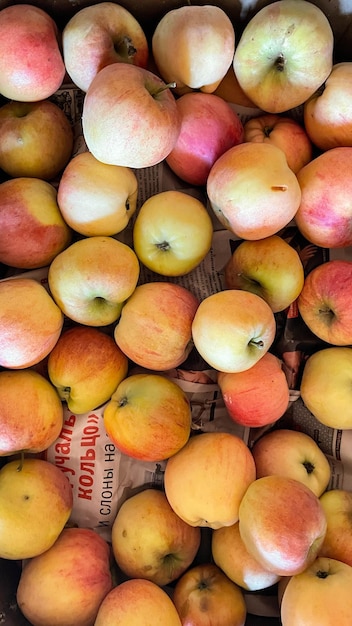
(0, 0, 352, 626)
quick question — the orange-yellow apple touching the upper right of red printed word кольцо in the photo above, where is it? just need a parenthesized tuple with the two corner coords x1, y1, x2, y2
(104, 372, 192, 462)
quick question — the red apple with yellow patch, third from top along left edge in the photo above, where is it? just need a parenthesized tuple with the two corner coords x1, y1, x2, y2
(0, 177, 72, 269)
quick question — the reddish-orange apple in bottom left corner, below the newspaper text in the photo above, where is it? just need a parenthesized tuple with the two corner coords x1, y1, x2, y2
(16, 527, 113, 626)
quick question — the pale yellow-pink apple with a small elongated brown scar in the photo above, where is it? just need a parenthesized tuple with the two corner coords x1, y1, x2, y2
(207, 141, 301, 239)
